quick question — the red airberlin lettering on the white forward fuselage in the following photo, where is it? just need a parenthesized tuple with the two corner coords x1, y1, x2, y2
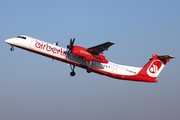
(35, 40, 66, 56)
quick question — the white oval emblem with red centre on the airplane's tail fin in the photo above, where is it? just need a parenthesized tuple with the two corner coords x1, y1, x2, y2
(147, 60, 163, 77)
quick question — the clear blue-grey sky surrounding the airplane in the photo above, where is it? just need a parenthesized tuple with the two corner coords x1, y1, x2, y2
(0, 0, 180, 120)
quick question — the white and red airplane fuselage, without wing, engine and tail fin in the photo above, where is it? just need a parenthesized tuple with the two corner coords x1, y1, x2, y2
(6, 35, 157, 82)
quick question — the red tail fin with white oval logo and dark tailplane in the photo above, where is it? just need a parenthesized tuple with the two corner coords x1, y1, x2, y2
(139, 54, 174, 79)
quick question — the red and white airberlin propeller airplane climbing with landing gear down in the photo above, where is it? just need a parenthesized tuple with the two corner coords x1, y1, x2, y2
(5, 35, 174, 83)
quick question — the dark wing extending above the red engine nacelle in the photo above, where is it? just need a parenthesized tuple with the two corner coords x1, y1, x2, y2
(87, 42, 114, 54)
